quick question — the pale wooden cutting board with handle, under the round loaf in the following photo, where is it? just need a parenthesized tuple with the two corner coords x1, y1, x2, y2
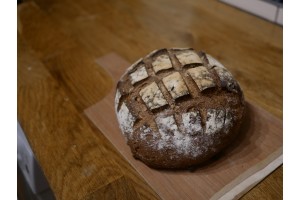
(84, 53, 282, 200)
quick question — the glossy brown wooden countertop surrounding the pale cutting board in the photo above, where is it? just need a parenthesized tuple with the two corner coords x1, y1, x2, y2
(18, 0, 283, 200)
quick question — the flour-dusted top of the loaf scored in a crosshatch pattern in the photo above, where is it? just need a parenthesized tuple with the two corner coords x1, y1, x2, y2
(115, 48, 241, 161)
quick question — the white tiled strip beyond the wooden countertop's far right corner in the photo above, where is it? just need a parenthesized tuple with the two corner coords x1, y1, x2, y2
(221, 0, 282, 25)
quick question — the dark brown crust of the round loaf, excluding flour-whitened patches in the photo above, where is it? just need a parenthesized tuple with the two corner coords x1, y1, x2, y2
(117, 49, 245, 169)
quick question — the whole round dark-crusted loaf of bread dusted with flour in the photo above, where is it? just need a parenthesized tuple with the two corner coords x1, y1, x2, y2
(115, 48, 245, 169)
